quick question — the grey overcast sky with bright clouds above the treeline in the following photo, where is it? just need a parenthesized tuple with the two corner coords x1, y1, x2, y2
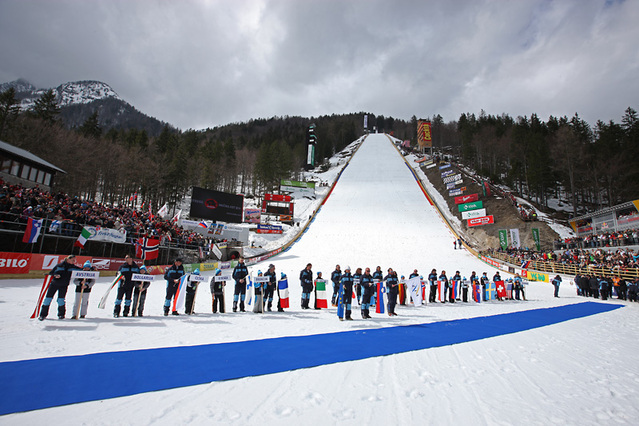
(0, 0, 639, 130)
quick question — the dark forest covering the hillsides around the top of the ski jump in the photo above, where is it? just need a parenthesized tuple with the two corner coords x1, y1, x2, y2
(0, 89, 639, 220)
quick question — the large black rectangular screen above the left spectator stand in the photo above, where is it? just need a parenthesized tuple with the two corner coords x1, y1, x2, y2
(189, 186, 244, 223)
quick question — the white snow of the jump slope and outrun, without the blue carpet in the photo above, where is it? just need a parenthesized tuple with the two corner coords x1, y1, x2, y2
(0, 134, 639, 425)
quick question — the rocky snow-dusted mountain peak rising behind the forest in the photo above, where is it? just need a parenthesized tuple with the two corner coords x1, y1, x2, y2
(0, 79, 175, 136)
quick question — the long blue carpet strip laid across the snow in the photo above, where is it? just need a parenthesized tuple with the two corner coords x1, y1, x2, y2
(0, 302, 621, 415)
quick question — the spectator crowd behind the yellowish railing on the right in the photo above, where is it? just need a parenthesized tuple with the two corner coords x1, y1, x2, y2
(484, 248, 639, 270)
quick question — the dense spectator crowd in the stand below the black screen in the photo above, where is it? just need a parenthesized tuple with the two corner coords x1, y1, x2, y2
(0, 178, 216, 246)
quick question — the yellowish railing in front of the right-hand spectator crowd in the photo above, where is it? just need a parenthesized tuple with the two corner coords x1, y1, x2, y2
(486, 252, 639, 280)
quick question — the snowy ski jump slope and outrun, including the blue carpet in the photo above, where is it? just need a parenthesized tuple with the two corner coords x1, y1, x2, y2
(0, 134, 639, 425)
